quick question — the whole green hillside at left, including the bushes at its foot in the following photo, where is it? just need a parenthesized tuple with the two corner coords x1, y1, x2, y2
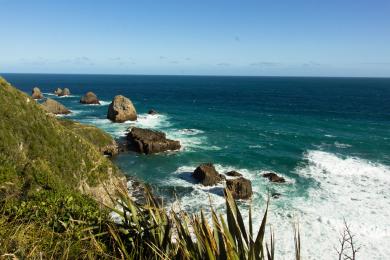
(0, 77, 123, 259)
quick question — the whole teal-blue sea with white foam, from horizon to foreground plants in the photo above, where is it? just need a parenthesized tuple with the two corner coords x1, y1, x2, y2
(3, 74, 390, 259)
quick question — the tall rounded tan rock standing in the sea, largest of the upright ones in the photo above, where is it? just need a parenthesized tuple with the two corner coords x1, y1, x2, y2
(107, 95, 137, 123)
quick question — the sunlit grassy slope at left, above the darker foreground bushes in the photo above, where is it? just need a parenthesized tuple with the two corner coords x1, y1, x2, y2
(0, 77, 124, 200)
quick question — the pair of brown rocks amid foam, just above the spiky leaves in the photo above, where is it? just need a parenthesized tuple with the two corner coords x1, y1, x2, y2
(192, 163, 253, 199)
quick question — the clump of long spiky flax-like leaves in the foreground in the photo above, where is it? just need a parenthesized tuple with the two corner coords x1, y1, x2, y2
(104, 186, 301, 260)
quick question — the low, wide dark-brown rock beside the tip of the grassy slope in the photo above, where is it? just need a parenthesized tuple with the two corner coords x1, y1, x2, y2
(127, 127, 181, 154)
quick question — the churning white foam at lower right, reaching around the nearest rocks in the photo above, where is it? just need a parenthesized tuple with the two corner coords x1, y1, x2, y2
(164, 151, 390, 259)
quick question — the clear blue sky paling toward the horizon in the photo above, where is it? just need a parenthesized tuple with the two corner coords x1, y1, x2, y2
(0, 0, 390, 77)
